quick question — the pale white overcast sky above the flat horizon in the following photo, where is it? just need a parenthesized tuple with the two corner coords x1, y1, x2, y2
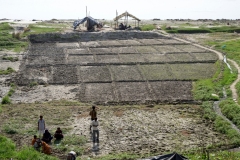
(0, 0, 240, 20)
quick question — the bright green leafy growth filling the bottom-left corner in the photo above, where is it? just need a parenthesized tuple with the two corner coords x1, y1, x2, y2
(0, 135, 57, 160)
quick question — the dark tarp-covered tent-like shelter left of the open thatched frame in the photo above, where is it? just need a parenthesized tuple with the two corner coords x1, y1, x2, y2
(73, 16, 102, 31)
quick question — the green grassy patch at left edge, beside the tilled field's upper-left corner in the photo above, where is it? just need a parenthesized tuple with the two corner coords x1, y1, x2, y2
(0, 23, 28, 52)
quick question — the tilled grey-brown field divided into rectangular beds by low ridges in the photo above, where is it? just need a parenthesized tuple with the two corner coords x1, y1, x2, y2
(16, 32, 218, 103)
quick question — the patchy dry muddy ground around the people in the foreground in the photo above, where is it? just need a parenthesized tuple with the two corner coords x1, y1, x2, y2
(0, 102, 226, 159)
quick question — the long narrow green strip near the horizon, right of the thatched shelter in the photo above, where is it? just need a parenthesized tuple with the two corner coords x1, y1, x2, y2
(165, 26, 240, 34)
